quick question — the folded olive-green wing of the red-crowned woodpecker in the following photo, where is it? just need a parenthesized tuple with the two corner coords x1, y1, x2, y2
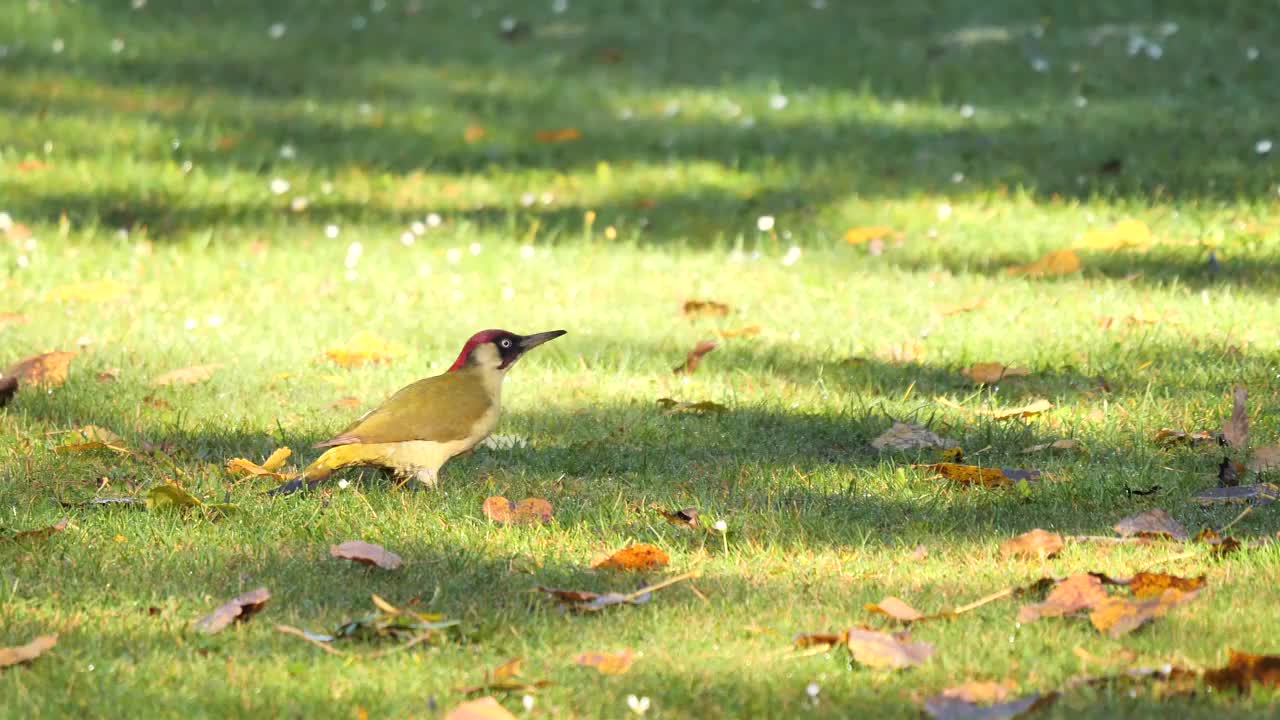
(316, 370, 490, 447)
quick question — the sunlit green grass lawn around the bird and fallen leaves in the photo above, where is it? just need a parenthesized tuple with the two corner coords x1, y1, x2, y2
(0, 0, 1280, 719)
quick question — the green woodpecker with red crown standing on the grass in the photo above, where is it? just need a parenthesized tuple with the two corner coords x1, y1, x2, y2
(285, 331, 564, 492)
